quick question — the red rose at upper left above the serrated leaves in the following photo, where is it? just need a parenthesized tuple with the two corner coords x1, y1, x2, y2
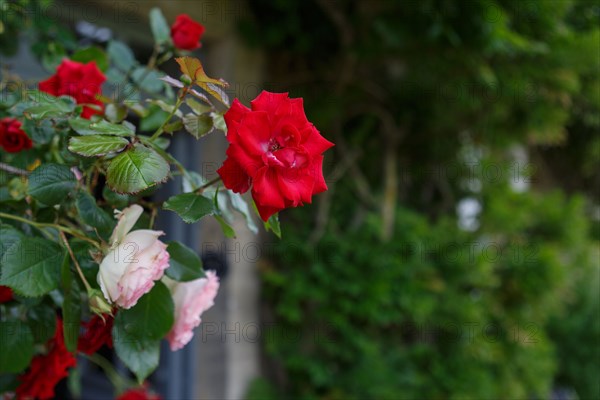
(39, 60, 106, 119)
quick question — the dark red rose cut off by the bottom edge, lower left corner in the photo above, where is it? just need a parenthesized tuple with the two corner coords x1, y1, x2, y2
(16, 318, 77, 399)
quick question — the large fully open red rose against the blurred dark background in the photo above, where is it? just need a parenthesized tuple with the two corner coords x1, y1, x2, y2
(217, 91, 333, 221)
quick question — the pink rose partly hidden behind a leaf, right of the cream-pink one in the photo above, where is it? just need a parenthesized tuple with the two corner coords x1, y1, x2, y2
(163, 271, 219, 351)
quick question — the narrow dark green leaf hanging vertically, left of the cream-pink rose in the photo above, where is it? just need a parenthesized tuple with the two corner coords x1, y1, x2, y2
(61, 253, 81, 353)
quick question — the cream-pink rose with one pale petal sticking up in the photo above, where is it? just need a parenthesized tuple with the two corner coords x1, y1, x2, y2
(98, 205, 169, 308)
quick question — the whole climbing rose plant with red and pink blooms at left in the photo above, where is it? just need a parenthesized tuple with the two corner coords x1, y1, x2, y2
(0, 9, 333, 399)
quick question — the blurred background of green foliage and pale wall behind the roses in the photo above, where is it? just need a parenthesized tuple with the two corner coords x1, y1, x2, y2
(0, 0, 600, 400)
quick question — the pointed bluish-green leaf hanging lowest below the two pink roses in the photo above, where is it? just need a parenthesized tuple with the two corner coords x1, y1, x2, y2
(112, 332, 160, 384)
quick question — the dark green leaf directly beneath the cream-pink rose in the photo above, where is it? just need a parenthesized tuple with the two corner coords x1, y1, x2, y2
(115, 281, 174, 340)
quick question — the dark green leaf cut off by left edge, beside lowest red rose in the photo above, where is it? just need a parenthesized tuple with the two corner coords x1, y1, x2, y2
(0, 320, 33, 373)
